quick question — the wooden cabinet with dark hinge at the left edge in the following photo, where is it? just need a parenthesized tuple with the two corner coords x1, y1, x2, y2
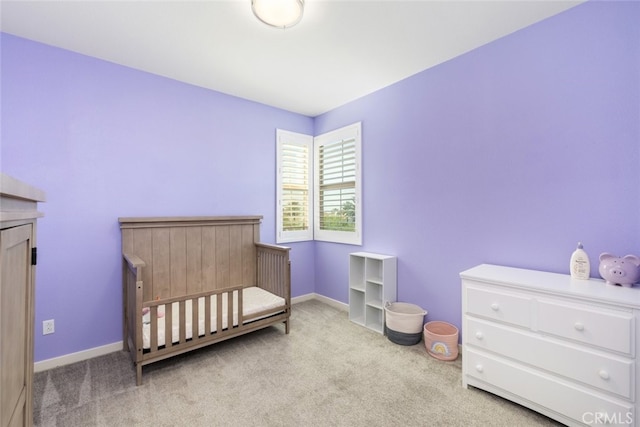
(0, 174, 45, 427)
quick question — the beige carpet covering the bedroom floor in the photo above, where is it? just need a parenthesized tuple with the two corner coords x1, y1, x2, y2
(34, 300, 558, 427)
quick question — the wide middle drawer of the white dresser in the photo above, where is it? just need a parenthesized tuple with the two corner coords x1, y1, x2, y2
(463, 319, 635, 399)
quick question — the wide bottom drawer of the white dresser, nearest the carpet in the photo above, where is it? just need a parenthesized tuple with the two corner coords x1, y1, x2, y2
(462, 349, 635, 425)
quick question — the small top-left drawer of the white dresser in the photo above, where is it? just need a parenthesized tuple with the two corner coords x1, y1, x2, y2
(466, 285, 532, 328)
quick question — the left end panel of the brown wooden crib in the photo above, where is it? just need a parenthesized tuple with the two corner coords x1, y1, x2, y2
(122, 253, 146, 360)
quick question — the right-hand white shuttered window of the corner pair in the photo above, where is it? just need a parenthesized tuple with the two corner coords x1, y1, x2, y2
(314, 123, 362, 245)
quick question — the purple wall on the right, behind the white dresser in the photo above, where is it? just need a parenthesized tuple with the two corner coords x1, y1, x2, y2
(315, 2, 640, 326)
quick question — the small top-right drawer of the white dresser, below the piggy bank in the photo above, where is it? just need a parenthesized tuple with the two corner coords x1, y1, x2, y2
(537, 299, 635, 355)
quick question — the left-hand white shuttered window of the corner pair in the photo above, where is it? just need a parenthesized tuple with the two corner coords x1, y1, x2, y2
(276, 129, 313, 243)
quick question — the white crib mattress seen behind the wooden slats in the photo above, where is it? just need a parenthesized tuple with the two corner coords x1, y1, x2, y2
(142, 286, 285, 350)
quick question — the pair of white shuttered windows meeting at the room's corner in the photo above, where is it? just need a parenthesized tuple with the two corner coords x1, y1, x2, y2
(276, 123, 362, 245)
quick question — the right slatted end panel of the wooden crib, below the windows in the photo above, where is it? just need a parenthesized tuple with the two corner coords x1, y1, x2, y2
(256, 243, 291, 306)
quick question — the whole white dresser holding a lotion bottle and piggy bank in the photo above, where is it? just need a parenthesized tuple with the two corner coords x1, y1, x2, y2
(460, 264, 640, 427)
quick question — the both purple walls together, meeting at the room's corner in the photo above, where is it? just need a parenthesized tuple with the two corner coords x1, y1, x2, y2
(1, 2, 640, 361)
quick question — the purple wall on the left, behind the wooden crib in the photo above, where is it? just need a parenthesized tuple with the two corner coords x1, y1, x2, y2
(1, 34, 314, 361)
